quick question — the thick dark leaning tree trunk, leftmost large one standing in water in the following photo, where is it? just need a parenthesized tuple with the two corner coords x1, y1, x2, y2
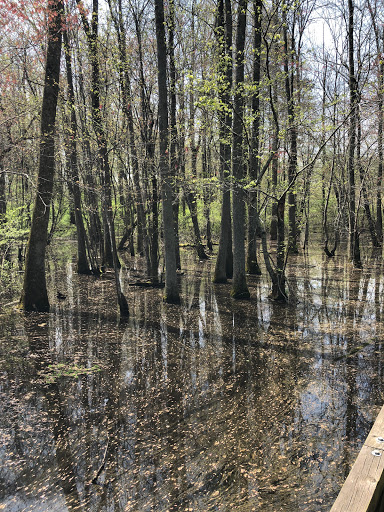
(21, 0, 64, 312)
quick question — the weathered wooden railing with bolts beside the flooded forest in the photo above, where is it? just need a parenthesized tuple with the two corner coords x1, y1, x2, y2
(331, 406, 384, 512)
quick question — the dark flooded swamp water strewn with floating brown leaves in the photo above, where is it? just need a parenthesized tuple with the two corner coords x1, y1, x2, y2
(0, 241, 384, 512)
